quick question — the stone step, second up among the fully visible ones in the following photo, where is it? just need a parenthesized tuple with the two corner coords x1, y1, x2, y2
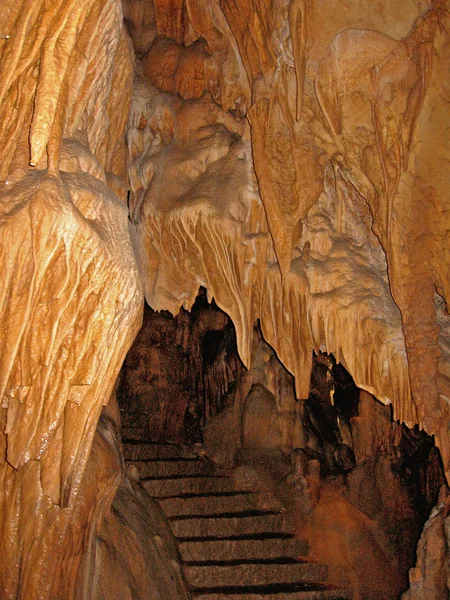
(179, 534, 308, 562)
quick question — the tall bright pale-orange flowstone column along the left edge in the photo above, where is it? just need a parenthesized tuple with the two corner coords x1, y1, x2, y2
(0, 0, 142, 600)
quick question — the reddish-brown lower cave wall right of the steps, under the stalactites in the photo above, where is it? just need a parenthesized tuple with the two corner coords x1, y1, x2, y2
(204, 332, 446, 600)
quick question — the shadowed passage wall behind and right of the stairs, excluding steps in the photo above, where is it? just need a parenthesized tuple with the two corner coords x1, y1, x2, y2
(117, 290, 444, 600)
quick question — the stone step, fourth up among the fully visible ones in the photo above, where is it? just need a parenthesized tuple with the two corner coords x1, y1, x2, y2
(159, 492, 258, 517)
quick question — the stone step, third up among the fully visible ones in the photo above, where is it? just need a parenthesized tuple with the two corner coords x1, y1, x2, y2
(169, 510, 283, 541)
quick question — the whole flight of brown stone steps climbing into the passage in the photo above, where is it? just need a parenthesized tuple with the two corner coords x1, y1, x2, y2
(124, 440, 351, 600)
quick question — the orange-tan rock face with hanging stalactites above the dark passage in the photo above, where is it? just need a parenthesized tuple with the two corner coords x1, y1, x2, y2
(127, 0, 450, 474)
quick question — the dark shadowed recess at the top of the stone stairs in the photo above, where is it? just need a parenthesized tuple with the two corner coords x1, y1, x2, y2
(117, 288, 245, 445)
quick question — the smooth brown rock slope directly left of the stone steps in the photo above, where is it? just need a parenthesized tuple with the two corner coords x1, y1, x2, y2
(86, 407, 189, 600)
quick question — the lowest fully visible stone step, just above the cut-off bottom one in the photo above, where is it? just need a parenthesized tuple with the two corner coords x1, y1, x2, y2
(184, 558, 328, 592)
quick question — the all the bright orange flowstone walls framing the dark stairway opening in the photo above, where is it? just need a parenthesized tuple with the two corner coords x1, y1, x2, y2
(0, 0, 450, 600)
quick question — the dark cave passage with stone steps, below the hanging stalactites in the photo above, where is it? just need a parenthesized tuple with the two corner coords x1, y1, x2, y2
(117, 290, 444, 600)
